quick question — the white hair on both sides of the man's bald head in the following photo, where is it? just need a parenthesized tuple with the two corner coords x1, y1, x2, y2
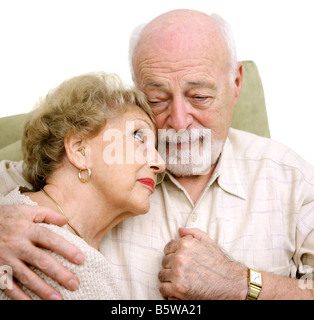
(129, 13, 238, 84)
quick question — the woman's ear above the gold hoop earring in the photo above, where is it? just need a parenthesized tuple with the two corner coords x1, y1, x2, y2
(64, 135, 88, 169)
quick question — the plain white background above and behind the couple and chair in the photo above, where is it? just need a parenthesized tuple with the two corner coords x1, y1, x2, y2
(0, 0, 314, 164)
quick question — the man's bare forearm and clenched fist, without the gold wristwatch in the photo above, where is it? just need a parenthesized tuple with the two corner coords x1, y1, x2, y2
(159, 229, 314, 300)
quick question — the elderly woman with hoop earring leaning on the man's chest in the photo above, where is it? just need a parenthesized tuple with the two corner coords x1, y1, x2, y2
(0, 73, 165, 299)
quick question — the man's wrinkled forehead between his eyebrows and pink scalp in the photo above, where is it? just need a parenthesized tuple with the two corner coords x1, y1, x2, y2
(133, 37, 228, 88)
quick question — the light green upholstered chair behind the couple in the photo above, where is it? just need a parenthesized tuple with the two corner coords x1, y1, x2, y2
(0, 61, 270, 161)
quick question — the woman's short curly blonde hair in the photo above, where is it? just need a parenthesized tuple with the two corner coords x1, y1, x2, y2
(22, 72, 155, 190)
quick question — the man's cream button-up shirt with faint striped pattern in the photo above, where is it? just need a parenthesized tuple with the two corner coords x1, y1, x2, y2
(0, 129, 314, 299)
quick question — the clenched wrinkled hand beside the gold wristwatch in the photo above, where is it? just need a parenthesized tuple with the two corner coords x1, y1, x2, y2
(159, 229, 248, 300)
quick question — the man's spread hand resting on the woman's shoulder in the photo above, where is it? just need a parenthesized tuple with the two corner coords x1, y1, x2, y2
(0, 205, 84, 300)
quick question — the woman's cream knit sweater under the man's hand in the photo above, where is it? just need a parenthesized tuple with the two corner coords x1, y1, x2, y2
(0, 188, 120, 300)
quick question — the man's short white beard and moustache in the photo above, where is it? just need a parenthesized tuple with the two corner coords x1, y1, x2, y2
(158, 128, 223, 177)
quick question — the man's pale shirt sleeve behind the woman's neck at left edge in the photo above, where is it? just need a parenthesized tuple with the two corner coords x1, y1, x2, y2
(0, 160, 32, 195)
